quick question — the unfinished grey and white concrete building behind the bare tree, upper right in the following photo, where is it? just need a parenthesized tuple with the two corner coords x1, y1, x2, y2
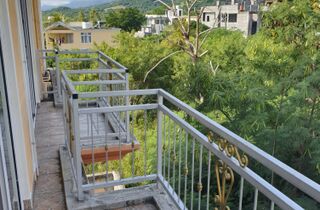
(201, 0, 260, 36)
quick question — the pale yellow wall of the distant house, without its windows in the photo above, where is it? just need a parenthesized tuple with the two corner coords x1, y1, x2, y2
(45, 29, 120, 50)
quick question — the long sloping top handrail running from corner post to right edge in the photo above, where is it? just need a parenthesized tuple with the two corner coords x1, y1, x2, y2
(159, 90, 320, 202)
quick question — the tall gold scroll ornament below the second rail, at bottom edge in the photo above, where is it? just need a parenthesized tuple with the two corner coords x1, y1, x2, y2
(214, 160, 234, 210)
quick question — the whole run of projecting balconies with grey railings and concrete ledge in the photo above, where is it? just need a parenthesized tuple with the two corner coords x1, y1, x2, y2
(33, 51, 320, 210)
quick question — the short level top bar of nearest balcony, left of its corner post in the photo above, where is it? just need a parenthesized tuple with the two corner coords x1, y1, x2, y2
(79, 89, 159, 98)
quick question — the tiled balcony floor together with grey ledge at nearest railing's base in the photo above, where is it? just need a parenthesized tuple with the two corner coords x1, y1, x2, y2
(33, 102, 177, 210)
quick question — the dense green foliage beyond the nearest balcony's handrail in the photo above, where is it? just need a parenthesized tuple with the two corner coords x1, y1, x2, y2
(89, 0, 320, 209)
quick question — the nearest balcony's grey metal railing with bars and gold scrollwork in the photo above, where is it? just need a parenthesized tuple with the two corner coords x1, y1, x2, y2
(62, 70, 320, 209)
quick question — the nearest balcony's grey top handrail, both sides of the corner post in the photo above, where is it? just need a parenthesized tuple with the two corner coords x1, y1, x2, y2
(72, 89, 320, 202)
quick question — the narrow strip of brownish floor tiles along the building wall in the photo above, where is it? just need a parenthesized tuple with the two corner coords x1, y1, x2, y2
(33, 102, 66, 210)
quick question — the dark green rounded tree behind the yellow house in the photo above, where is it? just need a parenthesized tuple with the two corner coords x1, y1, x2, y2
(106, 8, 146, 32)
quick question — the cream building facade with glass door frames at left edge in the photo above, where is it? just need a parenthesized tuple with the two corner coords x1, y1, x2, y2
(0, 0, 43, 210)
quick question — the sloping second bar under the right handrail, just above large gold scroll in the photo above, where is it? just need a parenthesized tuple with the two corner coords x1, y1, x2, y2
(159, 105, 302, 209)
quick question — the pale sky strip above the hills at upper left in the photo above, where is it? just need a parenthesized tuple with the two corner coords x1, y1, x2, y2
(41, 0, 112, 10)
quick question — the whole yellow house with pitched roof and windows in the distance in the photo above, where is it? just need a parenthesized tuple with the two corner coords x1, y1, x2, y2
(45, 22, 120, 50)
